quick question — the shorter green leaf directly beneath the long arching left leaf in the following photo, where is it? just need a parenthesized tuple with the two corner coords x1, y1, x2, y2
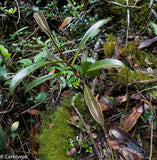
(25, 74, 57, 93)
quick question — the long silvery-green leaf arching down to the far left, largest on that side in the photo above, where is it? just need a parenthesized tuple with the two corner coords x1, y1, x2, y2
(9, 61, 64, 95)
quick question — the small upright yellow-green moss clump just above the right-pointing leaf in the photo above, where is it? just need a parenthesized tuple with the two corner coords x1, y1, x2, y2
(104, 33, 117, 57)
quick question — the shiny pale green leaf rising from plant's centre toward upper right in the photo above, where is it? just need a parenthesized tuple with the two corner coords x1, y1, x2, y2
(71, 17, 111, 65)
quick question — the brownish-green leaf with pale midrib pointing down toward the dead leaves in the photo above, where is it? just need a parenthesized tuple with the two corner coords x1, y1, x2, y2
(84, 84, 104, 126)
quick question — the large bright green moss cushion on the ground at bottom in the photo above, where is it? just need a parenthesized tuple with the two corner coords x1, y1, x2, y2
(39, 108, 74, 160)
